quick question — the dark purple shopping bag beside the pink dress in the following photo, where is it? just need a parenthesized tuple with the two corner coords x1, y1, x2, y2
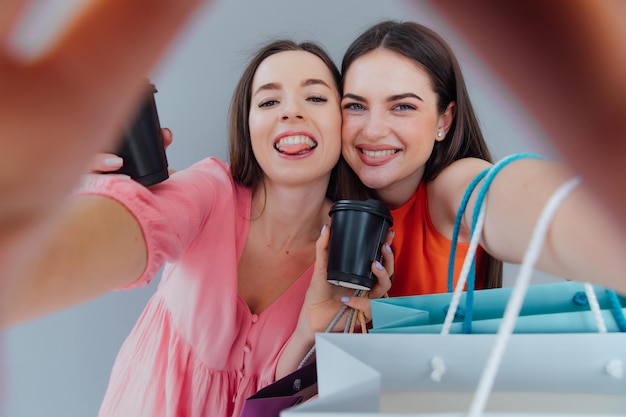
(240, 361, 317, 417)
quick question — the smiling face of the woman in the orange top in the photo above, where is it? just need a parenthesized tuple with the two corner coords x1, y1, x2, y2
(341, 48, 454, 207)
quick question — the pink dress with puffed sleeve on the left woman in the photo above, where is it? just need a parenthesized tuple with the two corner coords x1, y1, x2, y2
(81, 158, 313, 417)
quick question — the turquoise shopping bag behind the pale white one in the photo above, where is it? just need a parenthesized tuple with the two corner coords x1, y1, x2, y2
(370, 281, 626, 333)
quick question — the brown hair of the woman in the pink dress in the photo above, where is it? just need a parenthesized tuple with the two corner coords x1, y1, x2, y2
(229, 39, 350, 200)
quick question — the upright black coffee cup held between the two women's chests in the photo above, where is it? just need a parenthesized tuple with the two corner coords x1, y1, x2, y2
(327, 199, 393, 290)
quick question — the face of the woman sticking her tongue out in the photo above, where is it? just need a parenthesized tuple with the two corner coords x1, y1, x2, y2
(248, 51, 341, 188)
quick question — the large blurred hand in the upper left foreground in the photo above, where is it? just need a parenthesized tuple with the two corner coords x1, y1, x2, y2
(0, 0, 210, 316)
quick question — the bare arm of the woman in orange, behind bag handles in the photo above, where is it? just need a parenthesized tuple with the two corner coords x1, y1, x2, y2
(429, 158, 626, 293)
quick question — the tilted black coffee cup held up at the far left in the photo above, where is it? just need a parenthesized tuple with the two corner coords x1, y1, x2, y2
(106, 82, 169, 187)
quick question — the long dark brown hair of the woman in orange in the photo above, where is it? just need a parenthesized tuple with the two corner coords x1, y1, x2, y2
(341, 20, 502, 288)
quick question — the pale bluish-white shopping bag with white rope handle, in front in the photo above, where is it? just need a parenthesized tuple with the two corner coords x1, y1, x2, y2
(281, 333, 626, 417)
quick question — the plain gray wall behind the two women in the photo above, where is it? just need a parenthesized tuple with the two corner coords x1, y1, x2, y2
(0, 0, 556, 417)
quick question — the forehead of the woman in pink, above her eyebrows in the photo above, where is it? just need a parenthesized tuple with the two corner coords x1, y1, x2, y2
(252, 51, 335, 90)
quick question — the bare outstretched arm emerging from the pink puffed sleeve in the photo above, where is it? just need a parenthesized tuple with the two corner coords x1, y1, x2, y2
(0, 193, 148, 327)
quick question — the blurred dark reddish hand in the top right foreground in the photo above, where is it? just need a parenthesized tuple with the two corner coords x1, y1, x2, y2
(424, 0, 626, 237)
